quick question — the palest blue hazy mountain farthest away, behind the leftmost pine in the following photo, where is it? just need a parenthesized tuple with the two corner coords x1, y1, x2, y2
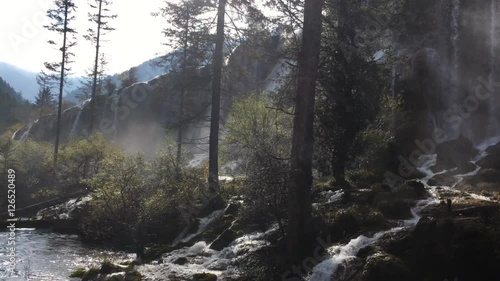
(0, 62, 80, 102)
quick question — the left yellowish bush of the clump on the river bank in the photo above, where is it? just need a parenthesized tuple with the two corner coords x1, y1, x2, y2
(81, 152, 154, 243)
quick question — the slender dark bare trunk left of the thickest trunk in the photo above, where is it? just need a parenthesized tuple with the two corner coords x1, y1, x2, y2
(208, 0, 226, 194)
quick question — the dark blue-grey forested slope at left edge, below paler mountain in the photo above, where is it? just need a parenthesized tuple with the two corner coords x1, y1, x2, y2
(0, 77, 32, 135)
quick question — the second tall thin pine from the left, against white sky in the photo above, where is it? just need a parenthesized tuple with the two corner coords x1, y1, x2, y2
(84, 0, 116, 133)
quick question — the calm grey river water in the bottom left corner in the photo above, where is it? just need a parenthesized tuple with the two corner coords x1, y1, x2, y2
(0, 229, 134, 281)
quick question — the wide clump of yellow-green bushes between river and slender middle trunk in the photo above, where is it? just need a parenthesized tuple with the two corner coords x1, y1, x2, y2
(81, 139, 206, 247)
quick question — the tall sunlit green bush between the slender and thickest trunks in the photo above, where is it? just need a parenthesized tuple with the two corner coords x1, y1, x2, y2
(223, 93, 292, 233)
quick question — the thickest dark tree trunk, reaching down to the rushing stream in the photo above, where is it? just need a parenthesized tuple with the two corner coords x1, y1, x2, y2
(287, 0, 323, 263)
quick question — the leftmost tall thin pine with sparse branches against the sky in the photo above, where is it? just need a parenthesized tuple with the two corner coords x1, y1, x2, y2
(44, 0, 76, 163)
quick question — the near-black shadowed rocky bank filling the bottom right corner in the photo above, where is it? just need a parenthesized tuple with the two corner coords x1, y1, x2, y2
(376, 216, 500, 281)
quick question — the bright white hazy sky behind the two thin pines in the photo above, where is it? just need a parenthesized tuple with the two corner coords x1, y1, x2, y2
(0, 0, 166, 75)
